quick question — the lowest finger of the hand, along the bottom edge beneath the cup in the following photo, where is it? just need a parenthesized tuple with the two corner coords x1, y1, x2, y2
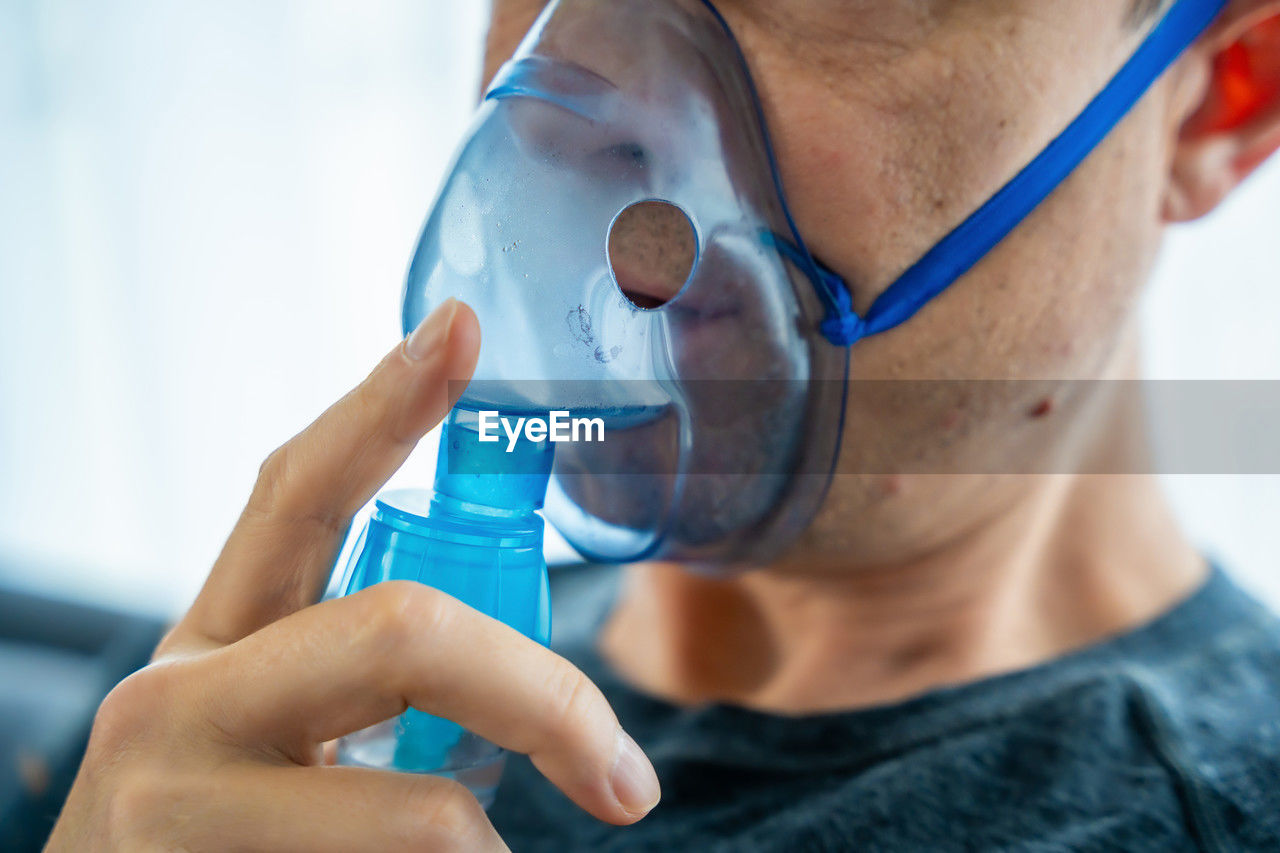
(126, 763, 507, 853)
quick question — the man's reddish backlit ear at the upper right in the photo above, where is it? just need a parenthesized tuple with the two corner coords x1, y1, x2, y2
(1164, 0, 1280, 223)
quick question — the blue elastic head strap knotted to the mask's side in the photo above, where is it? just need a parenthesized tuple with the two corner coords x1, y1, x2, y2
(771, 0, 1228, 346)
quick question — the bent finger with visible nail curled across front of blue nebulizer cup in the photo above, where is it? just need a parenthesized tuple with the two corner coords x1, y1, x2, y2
(205, 583, 659, 824)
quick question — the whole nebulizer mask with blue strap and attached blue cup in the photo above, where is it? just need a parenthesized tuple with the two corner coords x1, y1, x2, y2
(339, 0, 1224, 799)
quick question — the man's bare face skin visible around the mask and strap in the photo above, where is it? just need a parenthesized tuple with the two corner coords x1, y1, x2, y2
(486, 0, 1180, 569)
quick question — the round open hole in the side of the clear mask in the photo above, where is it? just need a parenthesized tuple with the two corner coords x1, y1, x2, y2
(608, 200, 698, 310)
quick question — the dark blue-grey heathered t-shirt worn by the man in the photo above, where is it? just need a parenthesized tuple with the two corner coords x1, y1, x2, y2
(490, 567, 1280, 853)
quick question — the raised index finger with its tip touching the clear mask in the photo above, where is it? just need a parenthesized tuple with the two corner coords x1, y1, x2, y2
(170, 300, 480, 644)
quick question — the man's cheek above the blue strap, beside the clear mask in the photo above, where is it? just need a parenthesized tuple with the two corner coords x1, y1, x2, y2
(739, 0, 1157, 326)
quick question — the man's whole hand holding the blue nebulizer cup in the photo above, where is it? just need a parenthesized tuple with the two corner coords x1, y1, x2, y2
(49, 301, 658, 850)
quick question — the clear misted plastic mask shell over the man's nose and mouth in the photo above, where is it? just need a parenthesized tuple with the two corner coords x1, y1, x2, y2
(404, 0, 847, 562)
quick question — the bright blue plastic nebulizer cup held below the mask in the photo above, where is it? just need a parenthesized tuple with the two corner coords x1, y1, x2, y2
(338, 409, 553, 807)
